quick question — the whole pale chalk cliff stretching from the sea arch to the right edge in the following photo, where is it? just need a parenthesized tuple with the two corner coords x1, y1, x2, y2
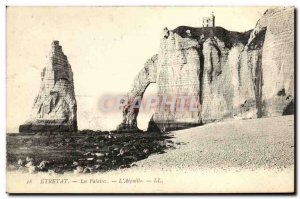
(118, 8, 294, 129)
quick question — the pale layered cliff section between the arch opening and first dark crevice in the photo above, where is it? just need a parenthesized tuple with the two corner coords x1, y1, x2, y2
(153, 29, 201, 128)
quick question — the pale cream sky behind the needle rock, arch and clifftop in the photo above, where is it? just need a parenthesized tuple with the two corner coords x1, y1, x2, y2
(6, 7, 268, 133)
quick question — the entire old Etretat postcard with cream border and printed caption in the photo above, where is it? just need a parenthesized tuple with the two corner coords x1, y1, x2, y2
(6, 6, 295, 193)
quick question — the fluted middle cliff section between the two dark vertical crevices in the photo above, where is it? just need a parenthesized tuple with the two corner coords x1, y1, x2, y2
(201, 29, 263, 123)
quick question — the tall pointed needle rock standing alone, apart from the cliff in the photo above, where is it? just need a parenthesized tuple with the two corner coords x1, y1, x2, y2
(19, 41, 77, 133)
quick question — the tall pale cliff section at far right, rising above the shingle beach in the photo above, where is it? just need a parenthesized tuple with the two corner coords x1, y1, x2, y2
(257, 8, 295, 116)
